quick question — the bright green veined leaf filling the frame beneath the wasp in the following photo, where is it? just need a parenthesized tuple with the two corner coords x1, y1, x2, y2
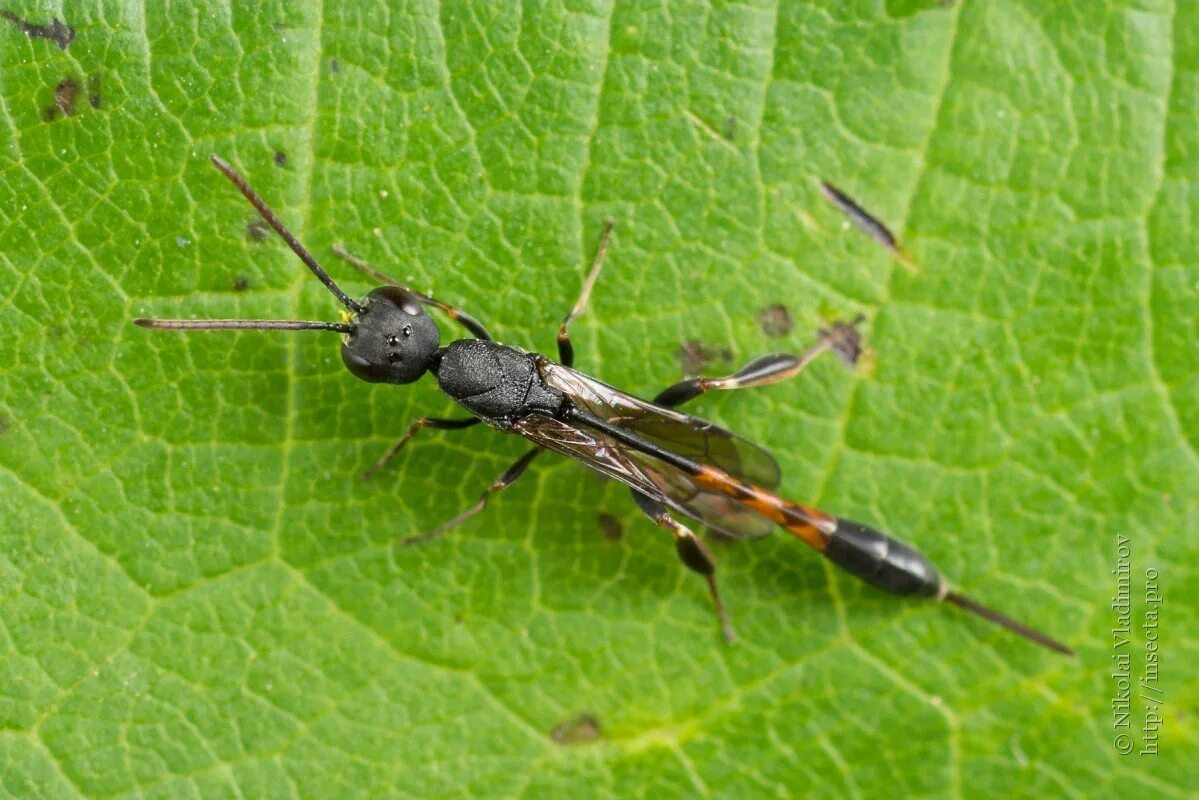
(0, 0, 1199, 798)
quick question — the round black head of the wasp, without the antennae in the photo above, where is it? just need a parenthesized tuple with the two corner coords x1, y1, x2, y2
(342, 287, 441, 384)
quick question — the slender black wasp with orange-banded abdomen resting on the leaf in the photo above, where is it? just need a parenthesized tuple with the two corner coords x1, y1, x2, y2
(133, 156, 1073, 655)
